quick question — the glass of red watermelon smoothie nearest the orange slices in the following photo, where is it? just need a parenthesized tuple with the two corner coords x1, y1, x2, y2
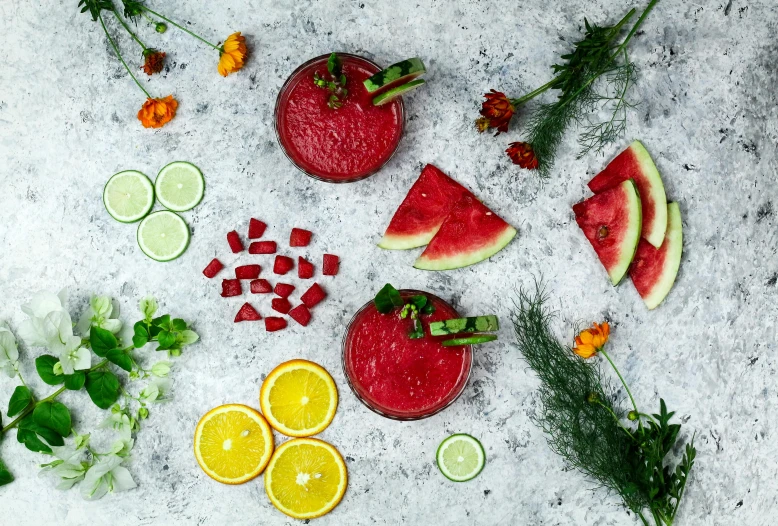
(343, 290, 473, 420)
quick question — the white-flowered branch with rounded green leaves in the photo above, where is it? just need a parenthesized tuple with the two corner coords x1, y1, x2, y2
(0, 292, 199, 499)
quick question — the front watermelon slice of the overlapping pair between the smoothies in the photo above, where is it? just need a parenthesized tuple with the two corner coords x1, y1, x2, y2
(413, 192, 516, 270)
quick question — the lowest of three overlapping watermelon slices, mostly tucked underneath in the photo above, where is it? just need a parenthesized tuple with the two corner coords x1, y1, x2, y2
(629, 203, 683, 309)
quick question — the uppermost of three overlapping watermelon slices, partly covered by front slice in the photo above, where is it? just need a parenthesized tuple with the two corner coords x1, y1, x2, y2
(589, 141, 667, 248)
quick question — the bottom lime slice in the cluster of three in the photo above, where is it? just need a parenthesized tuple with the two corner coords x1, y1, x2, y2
(138, 210, 189, 261)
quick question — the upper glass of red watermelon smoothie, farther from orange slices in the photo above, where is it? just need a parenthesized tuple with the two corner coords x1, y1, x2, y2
(275, 53, 405, 183)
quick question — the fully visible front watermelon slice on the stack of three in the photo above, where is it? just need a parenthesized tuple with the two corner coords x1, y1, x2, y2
(573, 179, 642, 285)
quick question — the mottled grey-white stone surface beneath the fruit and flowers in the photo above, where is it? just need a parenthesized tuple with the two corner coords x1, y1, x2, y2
(0, 0, 778, 526)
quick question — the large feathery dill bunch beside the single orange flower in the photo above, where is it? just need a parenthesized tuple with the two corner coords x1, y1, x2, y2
(513, 282, 696, 526)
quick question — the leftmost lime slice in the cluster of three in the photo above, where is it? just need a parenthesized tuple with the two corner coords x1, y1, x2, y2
(103, 170, 154, 223)
